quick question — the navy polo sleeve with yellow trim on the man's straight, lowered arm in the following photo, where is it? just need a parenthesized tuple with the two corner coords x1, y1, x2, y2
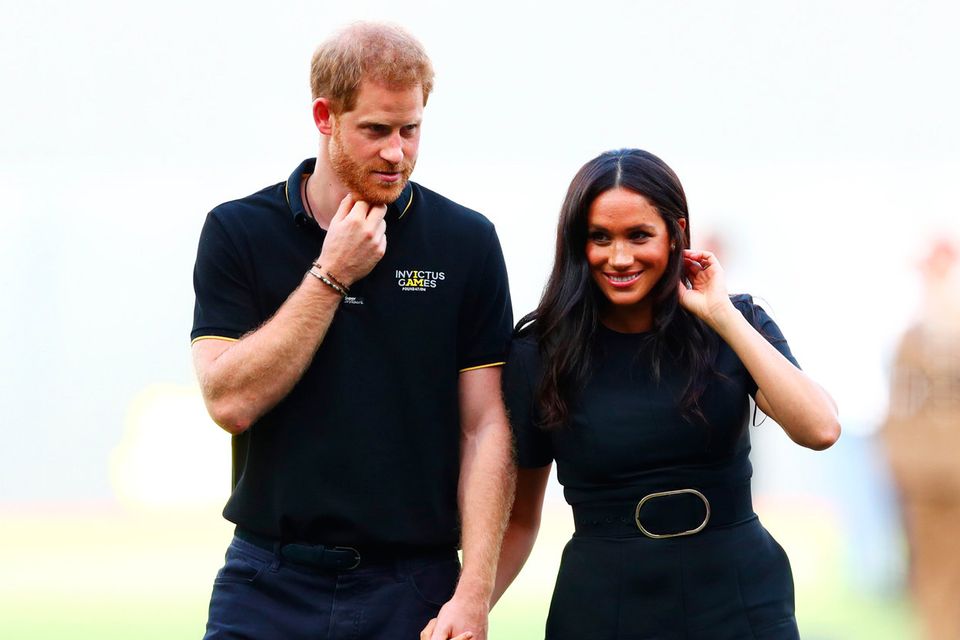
(457, 225, 513, 373)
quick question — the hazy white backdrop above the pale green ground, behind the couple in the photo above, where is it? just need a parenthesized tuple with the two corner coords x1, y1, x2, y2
(0, 0, 960, 502)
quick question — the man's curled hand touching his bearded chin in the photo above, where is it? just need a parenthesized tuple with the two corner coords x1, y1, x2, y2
(317, 194, 387, 286)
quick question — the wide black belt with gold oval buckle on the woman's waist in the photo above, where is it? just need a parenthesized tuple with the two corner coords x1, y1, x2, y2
(573, 483, 754, 538)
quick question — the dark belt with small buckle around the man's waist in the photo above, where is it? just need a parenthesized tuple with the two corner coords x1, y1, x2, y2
(234, 527, 456, 571)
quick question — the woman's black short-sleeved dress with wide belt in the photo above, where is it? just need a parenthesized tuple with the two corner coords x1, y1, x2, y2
(504, 296, 799, 640)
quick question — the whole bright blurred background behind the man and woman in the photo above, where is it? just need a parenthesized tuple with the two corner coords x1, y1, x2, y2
(0, 0, 960, 640)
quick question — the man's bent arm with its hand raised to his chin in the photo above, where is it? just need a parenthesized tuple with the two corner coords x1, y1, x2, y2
(193, 196, 386, 434)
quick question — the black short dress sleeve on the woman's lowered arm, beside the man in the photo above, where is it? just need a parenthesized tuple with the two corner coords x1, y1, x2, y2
(503, 339, 553, 468)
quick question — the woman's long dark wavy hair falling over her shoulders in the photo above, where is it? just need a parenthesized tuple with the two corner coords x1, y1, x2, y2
(517, 149, 717, 428)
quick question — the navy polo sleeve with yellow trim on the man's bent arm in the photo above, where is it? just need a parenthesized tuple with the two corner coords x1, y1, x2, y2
(190, 211, 260, 341)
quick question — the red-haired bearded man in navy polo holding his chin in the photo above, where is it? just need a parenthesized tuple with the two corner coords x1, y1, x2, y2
(192, 24, 513, 640)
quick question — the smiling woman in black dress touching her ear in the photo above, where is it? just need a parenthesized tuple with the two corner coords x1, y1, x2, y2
(497, 149, 840, 640)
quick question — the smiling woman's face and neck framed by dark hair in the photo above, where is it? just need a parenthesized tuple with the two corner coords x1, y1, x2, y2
(586, 188, 686, 333)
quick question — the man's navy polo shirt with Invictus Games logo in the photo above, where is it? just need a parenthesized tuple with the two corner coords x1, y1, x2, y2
(187, 160, 512, 546)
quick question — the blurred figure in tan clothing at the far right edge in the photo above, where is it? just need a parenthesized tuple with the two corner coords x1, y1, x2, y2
(883, 240, 960, 640)
